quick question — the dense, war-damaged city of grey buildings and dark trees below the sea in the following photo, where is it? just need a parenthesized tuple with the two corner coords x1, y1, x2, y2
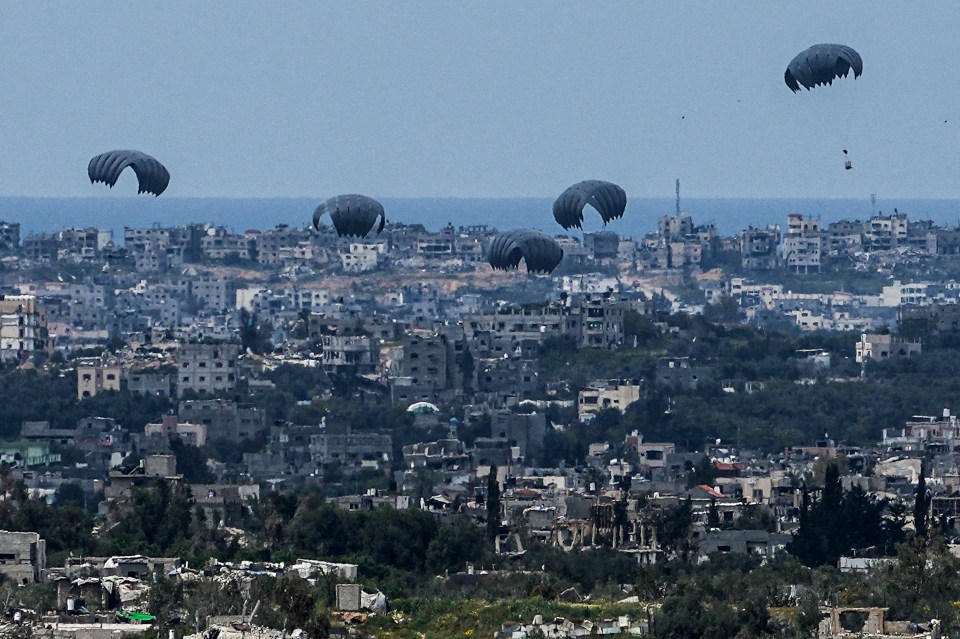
(0, 206, 960, 638)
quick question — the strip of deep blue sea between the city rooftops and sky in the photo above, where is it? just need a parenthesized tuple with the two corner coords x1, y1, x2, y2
(0, 196, 960, 242)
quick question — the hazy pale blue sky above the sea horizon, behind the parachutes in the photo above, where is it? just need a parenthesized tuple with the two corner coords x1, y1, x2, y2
(0, 0, 960, 198)
